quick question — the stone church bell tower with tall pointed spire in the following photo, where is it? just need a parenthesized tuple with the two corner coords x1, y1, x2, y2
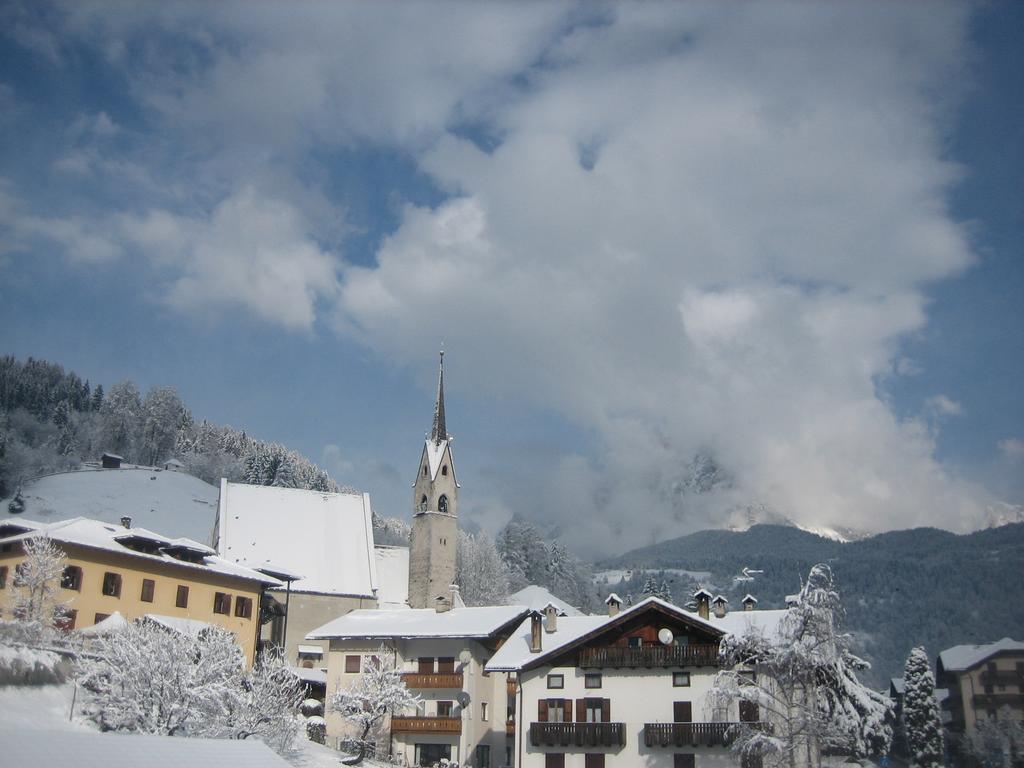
(409, 351, 459, 608)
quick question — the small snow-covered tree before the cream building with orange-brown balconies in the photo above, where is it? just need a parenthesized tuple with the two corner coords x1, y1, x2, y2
(330, 645, 420, 765)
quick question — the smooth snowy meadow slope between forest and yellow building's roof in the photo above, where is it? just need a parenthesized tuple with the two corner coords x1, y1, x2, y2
(0, 467, 218, 544)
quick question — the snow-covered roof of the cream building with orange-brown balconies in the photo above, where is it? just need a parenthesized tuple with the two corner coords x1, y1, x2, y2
(306, 605, 529, 640)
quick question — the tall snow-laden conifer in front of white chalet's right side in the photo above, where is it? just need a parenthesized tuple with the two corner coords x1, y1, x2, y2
(712, 564, 892, 768)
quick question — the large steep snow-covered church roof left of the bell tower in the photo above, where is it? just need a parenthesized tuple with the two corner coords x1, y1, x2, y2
(217, 480, 378, 597)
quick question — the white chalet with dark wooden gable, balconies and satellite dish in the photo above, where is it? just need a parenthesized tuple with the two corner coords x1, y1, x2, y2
(486, 593, 785, 768)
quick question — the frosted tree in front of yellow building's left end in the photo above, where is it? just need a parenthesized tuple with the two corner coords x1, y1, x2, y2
(13, 535, 68, 633)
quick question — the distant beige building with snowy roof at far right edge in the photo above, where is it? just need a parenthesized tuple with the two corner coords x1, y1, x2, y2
(935, 637, 1024, 734)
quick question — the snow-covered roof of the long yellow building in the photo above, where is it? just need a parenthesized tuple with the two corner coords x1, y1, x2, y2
(0, 517, 280, 586)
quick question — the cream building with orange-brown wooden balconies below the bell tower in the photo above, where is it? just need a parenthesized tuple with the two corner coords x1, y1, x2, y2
(307, 592, 528, 768)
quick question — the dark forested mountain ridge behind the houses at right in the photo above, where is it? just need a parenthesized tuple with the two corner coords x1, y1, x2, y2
(598, 523, 1024, 687)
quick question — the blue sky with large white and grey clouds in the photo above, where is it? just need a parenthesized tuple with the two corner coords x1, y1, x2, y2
(0, 1, 1024, 557)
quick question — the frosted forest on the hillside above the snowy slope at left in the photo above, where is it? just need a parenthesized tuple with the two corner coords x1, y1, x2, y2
(0, 355, 341, 498)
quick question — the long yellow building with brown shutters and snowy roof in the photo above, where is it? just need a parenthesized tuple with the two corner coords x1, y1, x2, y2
(0, 517, 281, 664)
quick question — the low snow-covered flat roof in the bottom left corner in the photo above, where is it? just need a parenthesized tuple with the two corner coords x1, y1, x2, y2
(0, 726, 289, 768)
